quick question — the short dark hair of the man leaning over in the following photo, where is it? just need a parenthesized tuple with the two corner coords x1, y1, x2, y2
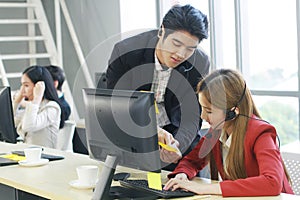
(162, 4, 208, 42)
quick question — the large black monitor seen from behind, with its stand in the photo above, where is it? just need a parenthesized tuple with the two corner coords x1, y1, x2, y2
(83, 88, 161, 199)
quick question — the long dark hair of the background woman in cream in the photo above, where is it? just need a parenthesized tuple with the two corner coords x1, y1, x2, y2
(23, 65, 65, 128)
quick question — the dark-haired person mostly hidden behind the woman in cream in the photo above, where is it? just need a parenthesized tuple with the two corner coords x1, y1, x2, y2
(46, 65, 71, 121)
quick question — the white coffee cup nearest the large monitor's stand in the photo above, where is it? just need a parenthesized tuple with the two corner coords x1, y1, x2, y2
(76, 165, 99, 185)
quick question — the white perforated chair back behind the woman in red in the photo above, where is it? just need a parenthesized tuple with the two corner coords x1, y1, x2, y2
(281, 152, 300, 195)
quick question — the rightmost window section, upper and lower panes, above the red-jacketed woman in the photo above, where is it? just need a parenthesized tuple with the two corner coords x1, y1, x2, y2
(241, 0, 299, 144)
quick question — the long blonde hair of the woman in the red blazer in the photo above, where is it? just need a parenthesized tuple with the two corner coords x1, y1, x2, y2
(197, 69, 260, 180)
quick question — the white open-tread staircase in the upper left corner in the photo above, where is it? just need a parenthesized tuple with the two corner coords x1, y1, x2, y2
(0, 0, 57, 83)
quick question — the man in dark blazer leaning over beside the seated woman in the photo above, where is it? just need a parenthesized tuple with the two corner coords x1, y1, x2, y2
(106, 5, 209, 170)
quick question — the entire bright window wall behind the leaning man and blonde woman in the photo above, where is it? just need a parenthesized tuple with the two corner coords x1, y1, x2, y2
(158, 0, 300, 145)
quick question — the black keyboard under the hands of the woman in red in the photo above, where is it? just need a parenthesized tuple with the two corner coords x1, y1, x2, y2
(119, 179, 195, 199)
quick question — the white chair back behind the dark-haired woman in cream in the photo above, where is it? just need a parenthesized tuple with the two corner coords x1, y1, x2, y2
(56, 120, 76, 152)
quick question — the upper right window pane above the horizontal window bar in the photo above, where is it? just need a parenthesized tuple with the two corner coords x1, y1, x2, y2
(245, 0, 298, 91)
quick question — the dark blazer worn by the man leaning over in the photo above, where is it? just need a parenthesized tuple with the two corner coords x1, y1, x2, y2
(106, 30, 209, 157)
